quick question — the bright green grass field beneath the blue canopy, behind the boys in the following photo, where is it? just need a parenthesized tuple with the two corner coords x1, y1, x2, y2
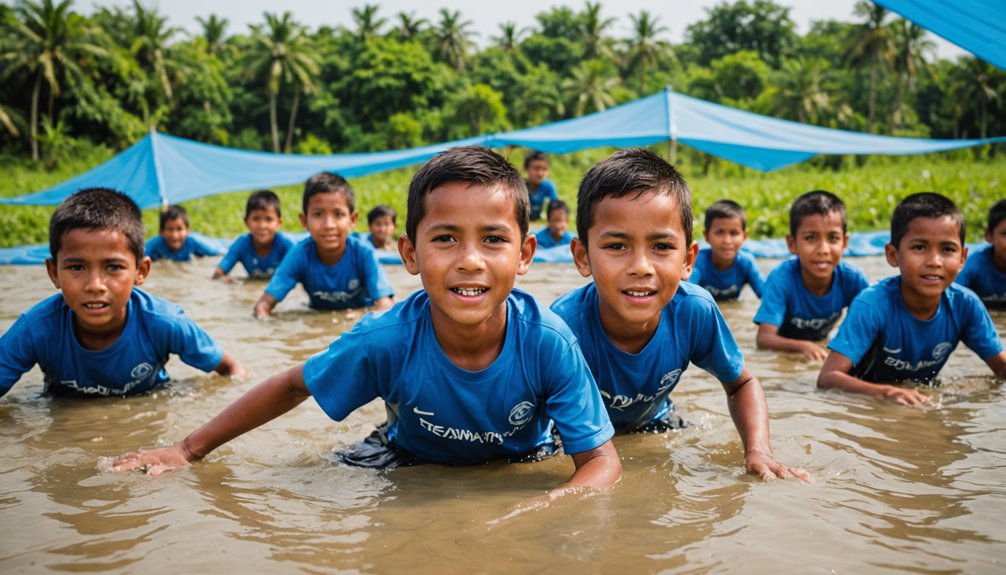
(0, 146, 1006, 247)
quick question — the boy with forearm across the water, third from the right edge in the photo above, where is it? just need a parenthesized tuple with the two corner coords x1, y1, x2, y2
(755, 190, 869, 361)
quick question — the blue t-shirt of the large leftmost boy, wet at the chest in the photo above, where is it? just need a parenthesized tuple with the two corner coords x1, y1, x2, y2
(0, 288, 223, 396)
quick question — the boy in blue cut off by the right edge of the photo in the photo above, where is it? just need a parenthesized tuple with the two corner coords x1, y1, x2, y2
(957, 200, 1006, 308)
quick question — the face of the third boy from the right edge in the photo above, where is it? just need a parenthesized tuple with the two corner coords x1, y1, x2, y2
(786, 212, 849, 281)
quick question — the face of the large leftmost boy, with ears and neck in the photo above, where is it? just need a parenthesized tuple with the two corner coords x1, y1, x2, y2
(45, 228, 150, 337)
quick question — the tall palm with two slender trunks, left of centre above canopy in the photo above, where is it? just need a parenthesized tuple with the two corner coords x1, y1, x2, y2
(247, 12, 321, 153)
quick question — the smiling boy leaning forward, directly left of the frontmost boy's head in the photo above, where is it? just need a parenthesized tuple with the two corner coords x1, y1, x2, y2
(255, 172, 393, 318)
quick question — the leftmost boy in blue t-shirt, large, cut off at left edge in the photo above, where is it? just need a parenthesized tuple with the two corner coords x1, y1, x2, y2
(0, 188, 244, 397)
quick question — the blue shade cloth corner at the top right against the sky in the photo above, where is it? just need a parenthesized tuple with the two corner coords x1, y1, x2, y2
(874, 0, 1006, 70)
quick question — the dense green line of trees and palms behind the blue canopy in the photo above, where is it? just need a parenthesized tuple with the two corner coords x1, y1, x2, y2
(0, 0, 1006, 164)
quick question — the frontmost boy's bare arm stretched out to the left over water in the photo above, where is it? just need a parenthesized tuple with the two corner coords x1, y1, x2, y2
(112, 364, 311, 475)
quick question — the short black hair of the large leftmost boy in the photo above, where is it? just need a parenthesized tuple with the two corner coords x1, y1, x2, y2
(49, 188, 143, 264)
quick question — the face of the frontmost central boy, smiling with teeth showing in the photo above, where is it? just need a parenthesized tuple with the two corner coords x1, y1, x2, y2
(398, 182, 534, 333)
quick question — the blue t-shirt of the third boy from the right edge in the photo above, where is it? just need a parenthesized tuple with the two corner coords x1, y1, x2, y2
(755, 257, 869, 341)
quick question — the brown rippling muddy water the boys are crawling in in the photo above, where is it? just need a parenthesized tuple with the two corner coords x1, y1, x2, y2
(0, 258, 1006, 574)
